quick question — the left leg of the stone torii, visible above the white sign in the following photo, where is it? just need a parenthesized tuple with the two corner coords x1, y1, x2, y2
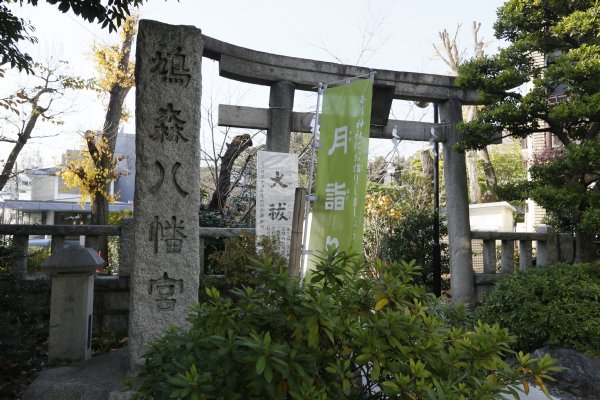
(267, 82, 295, 153)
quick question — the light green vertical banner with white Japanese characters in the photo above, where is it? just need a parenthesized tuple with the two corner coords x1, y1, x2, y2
(308, 79, 373, 269)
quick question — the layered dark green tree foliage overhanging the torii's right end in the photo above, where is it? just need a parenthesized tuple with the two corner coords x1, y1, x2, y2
(457, 0, 600, 254)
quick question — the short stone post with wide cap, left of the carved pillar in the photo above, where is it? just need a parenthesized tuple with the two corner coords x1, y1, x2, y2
(42, 245, 104, 361)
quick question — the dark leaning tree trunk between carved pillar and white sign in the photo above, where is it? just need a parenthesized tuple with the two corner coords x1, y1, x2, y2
(208, 134, 252, 214)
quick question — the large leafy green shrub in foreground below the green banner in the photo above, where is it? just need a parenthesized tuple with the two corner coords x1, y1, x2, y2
(137, 253, 556, 399)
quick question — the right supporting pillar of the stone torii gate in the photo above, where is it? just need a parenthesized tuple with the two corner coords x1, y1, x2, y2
(440, 100, 475, 305)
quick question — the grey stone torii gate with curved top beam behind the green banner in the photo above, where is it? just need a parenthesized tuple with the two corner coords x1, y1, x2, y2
(202, 31, 478, 304)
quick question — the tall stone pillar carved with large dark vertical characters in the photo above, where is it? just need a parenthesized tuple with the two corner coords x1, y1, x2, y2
(129, 20, 203, 368)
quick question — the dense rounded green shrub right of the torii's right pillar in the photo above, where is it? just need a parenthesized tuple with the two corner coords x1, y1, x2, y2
(475, 263, 600, 357)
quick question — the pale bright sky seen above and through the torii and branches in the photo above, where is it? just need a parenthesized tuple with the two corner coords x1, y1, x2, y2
(0, 0, 503, 165)
